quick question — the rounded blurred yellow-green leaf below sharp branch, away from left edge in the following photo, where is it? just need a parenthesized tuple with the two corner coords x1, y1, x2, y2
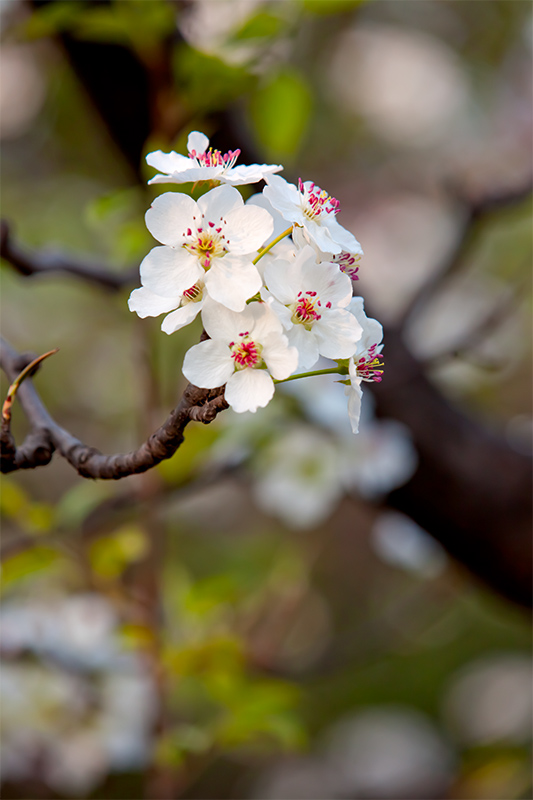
(89, 525, 149, 579)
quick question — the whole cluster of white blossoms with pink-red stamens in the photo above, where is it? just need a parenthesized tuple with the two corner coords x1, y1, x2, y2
(129, 131, 383, 433)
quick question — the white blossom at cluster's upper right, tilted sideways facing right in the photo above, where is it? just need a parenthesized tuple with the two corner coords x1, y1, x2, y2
(263, 175, 361, 254)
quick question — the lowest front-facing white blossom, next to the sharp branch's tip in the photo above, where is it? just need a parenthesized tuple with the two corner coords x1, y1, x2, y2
(183, 302, 298, 413)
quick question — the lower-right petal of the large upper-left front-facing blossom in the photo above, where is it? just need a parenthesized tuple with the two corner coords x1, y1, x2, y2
(205, 253, 263, 311)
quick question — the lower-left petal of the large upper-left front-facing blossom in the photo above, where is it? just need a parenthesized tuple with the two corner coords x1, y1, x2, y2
(140, 246, 204, 298)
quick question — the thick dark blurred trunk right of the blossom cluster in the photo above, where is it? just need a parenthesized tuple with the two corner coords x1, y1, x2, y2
(371, 329, 532, 607)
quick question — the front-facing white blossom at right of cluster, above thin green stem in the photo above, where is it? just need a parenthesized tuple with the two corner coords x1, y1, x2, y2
(262, 246, 362, 369)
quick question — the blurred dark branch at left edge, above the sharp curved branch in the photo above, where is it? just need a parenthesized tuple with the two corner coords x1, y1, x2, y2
(0, 220, 139, 292)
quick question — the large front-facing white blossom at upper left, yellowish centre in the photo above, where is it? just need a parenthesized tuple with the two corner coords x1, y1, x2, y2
(133, 186, 273, 316)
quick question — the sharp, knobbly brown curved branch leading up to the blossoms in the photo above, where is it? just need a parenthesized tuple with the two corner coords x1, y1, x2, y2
(0, 339, 228, 480)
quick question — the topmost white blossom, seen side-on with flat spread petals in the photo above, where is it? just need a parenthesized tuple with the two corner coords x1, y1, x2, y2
(146, 131, 283, 186)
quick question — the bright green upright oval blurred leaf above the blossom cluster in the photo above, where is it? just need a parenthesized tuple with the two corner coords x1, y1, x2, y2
(250, 68, 313, 160)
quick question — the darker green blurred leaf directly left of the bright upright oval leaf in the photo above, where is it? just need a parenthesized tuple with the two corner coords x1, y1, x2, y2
(173, 45, 256, 112)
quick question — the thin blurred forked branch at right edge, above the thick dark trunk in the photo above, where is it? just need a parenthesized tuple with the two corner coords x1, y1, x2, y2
(399, 181, 533, 331)
